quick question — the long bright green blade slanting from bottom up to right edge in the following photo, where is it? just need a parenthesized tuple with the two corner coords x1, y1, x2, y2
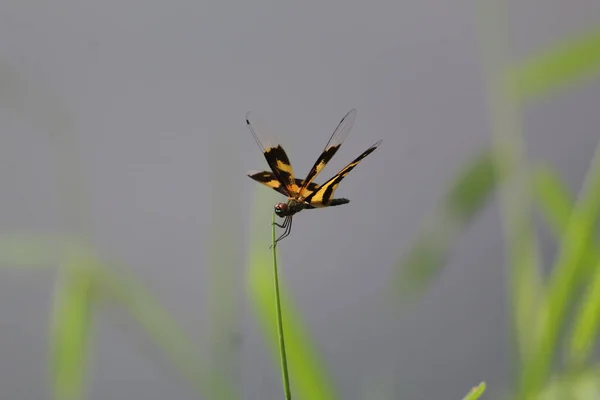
(520, 138, 600, 398)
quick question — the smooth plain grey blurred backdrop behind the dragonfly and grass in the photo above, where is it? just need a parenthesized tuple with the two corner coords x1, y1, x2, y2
(0, 0, 600, 400)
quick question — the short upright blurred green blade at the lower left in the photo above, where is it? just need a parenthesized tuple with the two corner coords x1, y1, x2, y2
(50, 259, 94, 400)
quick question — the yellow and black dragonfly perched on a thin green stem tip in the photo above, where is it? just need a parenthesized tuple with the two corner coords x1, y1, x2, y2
(246, 109, 382, 246)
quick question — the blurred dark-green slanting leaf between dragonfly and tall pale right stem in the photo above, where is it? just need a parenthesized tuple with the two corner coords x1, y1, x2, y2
(393, 150, 501, 296)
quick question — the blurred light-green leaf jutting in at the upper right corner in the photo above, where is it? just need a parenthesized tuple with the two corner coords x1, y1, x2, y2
(508, 24, 600, 101)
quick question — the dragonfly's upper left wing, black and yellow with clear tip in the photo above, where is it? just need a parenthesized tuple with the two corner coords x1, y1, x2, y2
(246, 111, 299, 197)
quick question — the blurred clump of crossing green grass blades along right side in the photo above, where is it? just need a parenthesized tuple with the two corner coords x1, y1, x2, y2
(395, 7, 600, 399)
